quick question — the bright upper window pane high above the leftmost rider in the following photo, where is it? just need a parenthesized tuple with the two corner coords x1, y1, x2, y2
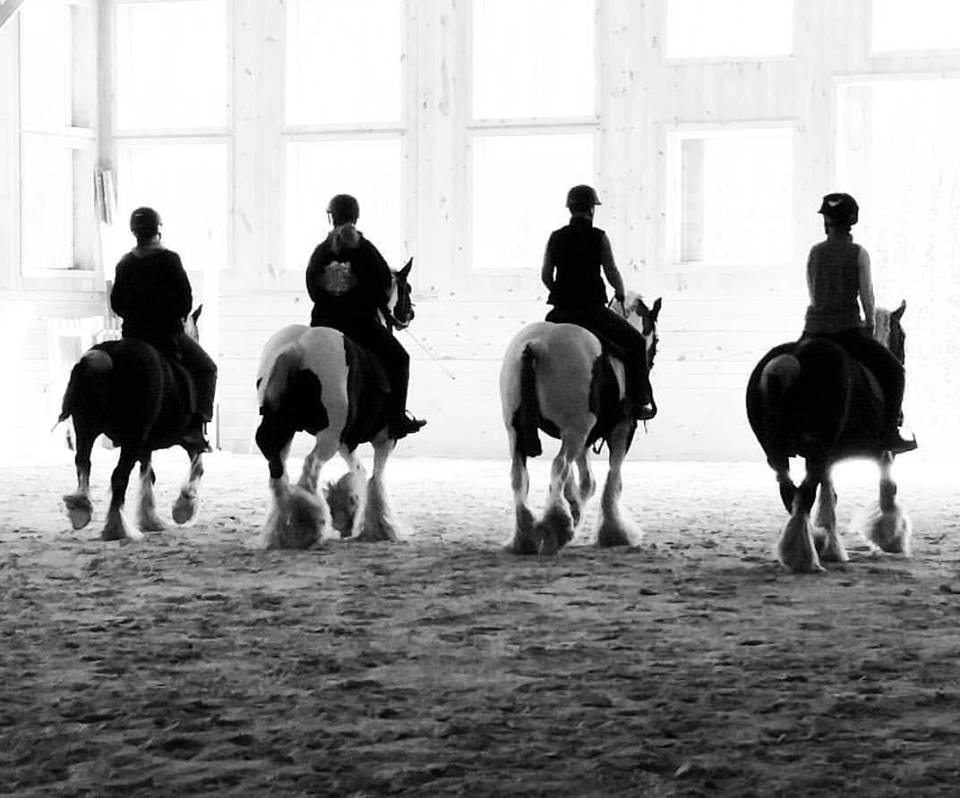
(117, 0, 227, 129)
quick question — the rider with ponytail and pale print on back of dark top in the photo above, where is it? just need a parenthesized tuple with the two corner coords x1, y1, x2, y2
(306, 194, 427, 439)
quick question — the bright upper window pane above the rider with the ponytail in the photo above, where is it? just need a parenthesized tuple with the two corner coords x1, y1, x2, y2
(287, 0, 403, 124)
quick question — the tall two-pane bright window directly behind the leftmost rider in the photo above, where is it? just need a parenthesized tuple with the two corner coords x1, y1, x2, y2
(112, 0, 230, 270)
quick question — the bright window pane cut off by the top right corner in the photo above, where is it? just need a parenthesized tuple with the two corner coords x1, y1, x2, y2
(873, 0, 960, 51)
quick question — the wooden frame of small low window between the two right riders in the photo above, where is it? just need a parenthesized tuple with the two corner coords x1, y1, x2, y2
(663, 119, 800, 274)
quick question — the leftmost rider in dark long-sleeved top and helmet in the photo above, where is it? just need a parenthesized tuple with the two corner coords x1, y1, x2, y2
(110, 208, 217, 451)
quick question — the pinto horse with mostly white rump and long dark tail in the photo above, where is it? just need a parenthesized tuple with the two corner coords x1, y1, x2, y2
(500, 293, 661, 555)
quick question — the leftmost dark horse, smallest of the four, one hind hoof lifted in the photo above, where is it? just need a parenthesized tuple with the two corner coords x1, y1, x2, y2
(57, 305, 205, 540)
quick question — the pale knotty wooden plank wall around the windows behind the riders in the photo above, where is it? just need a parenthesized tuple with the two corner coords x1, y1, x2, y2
(0, 0, 960, 459)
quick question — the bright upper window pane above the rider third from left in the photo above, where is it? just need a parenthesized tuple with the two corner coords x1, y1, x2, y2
(473, 0, 595, 119)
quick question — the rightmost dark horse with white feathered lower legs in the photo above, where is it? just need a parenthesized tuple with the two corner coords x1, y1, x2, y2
(746, 302, 911, 573)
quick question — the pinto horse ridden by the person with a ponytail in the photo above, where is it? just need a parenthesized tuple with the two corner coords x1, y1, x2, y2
(256, 258, 414, 549)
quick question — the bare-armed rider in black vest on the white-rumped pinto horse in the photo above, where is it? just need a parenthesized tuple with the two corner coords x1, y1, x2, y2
(541, 185, 657, 420)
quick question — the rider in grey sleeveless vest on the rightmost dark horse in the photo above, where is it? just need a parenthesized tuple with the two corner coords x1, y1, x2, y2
(802, 193, 917, 452)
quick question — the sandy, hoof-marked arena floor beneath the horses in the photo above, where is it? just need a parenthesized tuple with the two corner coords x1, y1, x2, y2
(0, 451, 960, 796)
